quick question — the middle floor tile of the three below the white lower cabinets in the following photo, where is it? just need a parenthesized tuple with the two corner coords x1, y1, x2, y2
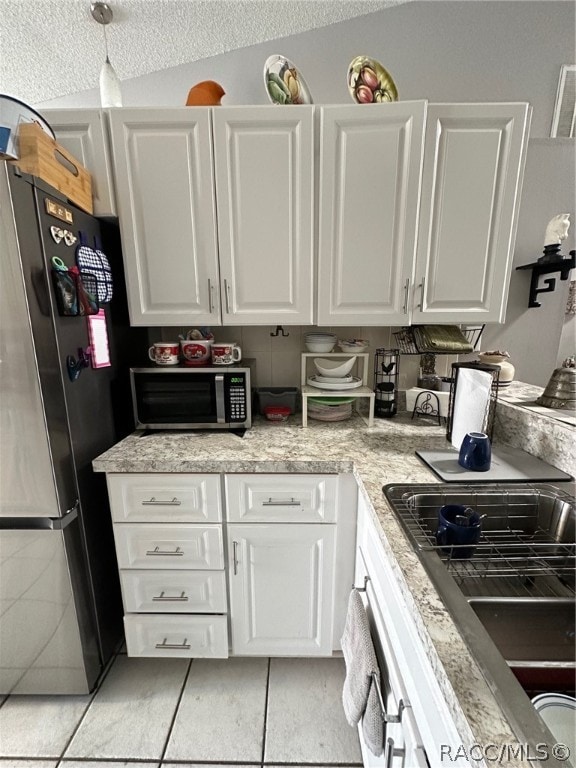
(164, 658, 268, 763)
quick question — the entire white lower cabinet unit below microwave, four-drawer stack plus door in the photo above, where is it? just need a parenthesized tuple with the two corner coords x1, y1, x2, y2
(107, 473, 358, 658)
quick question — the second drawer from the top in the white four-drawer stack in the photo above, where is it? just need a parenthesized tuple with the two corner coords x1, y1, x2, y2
(114, 523, 224, 570)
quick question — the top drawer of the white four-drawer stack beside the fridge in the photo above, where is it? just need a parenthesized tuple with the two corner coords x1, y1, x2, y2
(107, 473, 222, 523)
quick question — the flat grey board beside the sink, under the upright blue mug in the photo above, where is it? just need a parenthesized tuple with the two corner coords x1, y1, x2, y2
(416, 445, 574, 483)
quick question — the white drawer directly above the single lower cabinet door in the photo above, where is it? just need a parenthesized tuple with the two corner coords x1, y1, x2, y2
(225, 474, 338, 523)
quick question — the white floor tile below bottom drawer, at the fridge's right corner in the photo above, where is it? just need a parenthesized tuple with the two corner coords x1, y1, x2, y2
(64, 656, 189, 760)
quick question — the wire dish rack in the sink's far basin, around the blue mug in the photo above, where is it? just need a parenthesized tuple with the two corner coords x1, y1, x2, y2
(390, 486, 576, 598)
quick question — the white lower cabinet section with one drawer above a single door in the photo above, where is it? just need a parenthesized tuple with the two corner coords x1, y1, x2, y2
(225, 473, 357, 656)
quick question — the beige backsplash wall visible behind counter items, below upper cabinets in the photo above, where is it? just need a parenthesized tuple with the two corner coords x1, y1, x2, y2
(148, 325, 457, 389)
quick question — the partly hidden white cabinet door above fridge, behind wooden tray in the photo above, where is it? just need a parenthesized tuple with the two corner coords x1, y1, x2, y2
(42, 109, 117, 216)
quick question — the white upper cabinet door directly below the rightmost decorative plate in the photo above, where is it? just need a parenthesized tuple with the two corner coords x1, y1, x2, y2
(318, 101, 426, 326)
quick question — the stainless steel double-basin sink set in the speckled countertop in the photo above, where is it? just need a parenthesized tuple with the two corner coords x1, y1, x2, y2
(383, 483, 576, 760)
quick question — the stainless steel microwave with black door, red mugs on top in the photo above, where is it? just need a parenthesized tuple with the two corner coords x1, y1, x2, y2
(130, 359, 255, 429)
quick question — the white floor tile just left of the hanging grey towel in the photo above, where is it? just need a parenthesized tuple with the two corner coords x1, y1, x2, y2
(264, 659, 362, 765)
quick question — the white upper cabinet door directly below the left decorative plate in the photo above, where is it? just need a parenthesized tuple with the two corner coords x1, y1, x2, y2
(213, 106, 314, 325)
